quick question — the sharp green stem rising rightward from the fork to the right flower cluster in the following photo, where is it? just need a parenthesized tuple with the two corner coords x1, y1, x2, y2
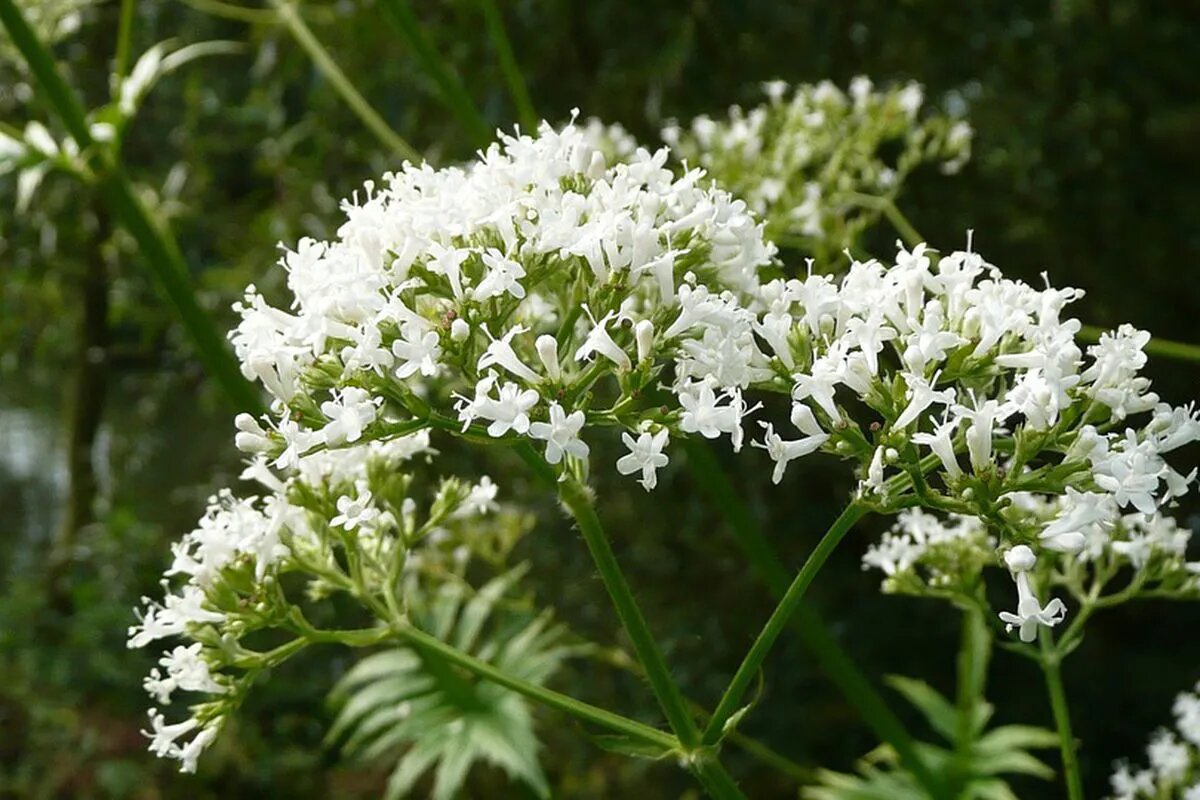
(702, 503, 866, 745)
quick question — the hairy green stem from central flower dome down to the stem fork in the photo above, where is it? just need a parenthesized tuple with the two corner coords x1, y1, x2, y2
(558, 476, 700, 750)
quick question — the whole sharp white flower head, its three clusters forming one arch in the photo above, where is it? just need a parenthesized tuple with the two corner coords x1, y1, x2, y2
(131, 115, 1200, 768)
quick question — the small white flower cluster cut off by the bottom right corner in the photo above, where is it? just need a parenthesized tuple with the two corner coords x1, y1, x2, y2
(1111, 685, 1200, 800)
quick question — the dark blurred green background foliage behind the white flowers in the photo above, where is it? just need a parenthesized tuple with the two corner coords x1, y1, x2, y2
(0, 0, 1200, 798)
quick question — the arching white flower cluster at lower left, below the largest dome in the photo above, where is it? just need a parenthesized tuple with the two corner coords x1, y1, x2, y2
(128, 432, 514, 772)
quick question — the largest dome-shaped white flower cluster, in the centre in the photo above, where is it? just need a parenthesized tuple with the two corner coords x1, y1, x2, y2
(232, 117, 774, 487)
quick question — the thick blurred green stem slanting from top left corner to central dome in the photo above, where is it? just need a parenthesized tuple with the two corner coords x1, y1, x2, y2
(0, 0, 263, 411)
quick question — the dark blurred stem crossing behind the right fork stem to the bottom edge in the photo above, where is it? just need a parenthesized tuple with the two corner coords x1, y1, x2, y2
(684, 439, 936, 790)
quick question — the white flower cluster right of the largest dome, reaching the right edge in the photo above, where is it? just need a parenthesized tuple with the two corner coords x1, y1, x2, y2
(756, 246, 1200, 630)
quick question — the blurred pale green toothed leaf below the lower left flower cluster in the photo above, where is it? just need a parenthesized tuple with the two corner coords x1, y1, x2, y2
(326, 567, 571, 800)
